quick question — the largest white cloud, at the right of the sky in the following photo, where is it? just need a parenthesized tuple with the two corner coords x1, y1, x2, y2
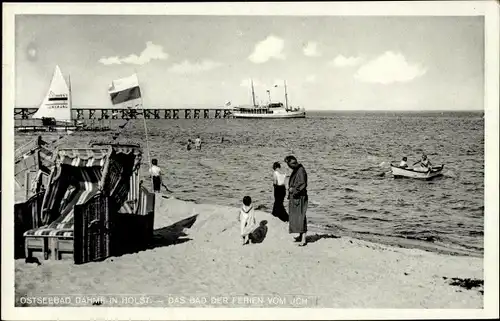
(354, 51, 427, 85)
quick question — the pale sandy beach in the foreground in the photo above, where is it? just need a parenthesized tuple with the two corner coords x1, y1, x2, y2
(15, 195, 483, 308)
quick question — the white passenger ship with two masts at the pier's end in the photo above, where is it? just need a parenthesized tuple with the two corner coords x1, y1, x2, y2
(232, 80, 306, 119)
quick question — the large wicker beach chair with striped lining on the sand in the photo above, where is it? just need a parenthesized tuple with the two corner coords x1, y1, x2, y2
(24, 144, 154, 263)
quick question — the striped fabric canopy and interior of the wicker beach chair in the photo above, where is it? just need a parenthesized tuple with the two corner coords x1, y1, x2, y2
(42, 145, 142, 225)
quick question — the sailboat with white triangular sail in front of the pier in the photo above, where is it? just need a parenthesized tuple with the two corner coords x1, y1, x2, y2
(15, 66, 109, 132)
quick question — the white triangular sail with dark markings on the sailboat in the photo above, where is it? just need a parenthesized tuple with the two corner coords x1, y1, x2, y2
(33, 66, 72, 121)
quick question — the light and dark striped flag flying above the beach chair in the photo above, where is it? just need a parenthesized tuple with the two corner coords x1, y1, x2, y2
(108, 74, 142, 108)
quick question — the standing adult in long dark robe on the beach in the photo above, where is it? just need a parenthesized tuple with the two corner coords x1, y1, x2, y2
(285, 156, 308, 246)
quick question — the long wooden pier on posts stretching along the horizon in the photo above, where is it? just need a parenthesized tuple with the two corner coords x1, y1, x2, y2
(14, 108, 233, 120)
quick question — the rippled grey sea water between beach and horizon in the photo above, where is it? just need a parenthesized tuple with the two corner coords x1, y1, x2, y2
(16, 112, 484, 255)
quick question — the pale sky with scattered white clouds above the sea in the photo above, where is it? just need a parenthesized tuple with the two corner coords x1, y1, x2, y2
(15, 15, 484, 110)
